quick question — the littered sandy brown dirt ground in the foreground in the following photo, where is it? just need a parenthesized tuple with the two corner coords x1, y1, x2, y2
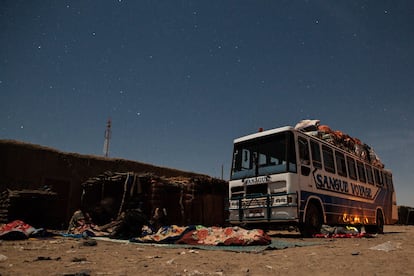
(0, 226, 414, 276)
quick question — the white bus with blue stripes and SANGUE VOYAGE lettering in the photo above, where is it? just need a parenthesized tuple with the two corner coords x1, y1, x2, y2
(229, 123, 398, 237)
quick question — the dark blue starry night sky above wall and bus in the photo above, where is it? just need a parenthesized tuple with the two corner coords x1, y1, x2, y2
(0, 0, 414, 206)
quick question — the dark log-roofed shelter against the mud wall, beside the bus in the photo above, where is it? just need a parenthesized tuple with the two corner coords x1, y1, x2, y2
(82, 172, 227, 229)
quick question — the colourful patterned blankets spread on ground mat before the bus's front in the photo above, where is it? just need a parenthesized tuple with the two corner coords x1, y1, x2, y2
(131, 225, 271, 246)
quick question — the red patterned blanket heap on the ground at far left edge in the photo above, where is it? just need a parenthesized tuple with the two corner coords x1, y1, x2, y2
(0, 220, 43, 240)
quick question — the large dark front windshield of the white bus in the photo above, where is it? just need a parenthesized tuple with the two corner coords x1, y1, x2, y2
(231, 131, 296, 180)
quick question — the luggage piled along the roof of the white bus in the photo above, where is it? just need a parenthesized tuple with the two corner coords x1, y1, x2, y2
(295, 120, 384, 168)
